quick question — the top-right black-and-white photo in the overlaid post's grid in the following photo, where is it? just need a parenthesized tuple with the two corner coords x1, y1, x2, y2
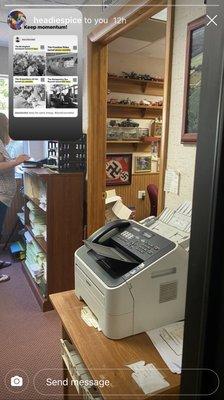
(46, 53, 78, 76)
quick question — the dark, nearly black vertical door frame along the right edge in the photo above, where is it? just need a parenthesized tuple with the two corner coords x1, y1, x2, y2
(180, 0, 224, 399)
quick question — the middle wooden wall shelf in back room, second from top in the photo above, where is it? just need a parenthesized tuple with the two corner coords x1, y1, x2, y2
(107, 103, 163, 119)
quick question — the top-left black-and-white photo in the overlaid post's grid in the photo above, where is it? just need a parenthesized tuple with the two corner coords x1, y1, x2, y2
(13, 52, 45, 76)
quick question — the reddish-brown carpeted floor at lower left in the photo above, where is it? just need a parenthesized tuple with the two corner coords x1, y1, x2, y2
(0, 254, 63, 400)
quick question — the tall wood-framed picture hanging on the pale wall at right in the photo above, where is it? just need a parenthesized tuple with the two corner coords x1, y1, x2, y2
(181, 16, 206, 143)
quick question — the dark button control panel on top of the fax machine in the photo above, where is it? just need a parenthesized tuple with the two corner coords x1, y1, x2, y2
(111, 222, 175, 262)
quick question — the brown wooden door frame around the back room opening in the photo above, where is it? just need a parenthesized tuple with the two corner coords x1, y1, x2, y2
(87, 0, 175, 235)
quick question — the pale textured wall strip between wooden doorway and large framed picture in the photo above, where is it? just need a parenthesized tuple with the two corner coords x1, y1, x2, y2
(165, 0, 205, 208)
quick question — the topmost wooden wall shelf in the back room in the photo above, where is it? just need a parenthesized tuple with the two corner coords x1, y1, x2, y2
(108, 76, 164, 96)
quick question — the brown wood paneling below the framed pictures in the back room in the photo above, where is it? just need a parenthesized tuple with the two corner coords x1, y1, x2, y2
(107, 173, 159, 221)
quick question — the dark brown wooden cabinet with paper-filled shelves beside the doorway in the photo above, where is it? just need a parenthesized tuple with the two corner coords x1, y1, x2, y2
(23, 169, 84, 311)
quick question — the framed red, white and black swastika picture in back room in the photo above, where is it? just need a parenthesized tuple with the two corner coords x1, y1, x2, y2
(106, 153, 132, 186)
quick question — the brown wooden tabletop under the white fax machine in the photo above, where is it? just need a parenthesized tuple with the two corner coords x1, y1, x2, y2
(50, 290, 180, 400)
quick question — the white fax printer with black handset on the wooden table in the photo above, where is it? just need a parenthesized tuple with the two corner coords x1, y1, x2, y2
(75, 203, 191, 339)
